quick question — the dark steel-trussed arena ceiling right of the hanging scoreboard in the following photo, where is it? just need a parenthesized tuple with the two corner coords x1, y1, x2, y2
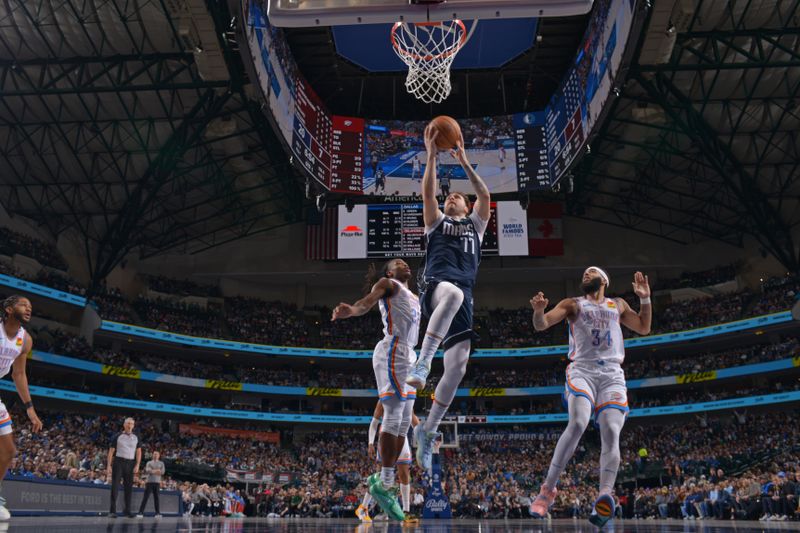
(567, 0, 800, 272)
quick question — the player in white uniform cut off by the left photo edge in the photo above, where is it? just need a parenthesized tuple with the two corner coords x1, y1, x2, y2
(0, 296, 42, 520)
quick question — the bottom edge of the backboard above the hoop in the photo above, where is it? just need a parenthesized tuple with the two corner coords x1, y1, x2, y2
(267, 0, 592, 28)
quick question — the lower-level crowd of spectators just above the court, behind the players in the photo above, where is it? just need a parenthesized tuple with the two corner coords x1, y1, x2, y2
(11, 409, 800, 520)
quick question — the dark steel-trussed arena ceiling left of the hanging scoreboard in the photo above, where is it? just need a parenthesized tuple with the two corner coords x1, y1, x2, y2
(0, 0, 302, 286)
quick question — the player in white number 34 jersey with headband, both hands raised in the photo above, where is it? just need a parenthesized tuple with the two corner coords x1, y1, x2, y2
(530, 267, 652, 527)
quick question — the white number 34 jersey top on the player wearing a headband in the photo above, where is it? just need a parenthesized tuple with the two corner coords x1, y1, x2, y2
(568, 296, 625, 364)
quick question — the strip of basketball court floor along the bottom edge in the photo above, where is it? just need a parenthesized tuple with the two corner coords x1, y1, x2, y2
(0, 517, 800, 533)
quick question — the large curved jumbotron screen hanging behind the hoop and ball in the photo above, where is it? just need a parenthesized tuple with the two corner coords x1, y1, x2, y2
(247, 0, 635, 192)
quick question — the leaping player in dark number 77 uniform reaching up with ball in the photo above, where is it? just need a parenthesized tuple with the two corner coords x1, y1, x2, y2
(406, 125, 491, 471)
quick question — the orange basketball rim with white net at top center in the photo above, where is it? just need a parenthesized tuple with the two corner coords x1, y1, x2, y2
(391, 19, 478, 104)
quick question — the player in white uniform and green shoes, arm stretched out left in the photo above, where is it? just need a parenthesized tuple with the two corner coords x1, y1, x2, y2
(332, 259, 420, 520)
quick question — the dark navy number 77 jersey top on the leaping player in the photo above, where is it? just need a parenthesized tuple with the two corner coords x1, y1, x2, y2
(418, 211, 488, 288)
